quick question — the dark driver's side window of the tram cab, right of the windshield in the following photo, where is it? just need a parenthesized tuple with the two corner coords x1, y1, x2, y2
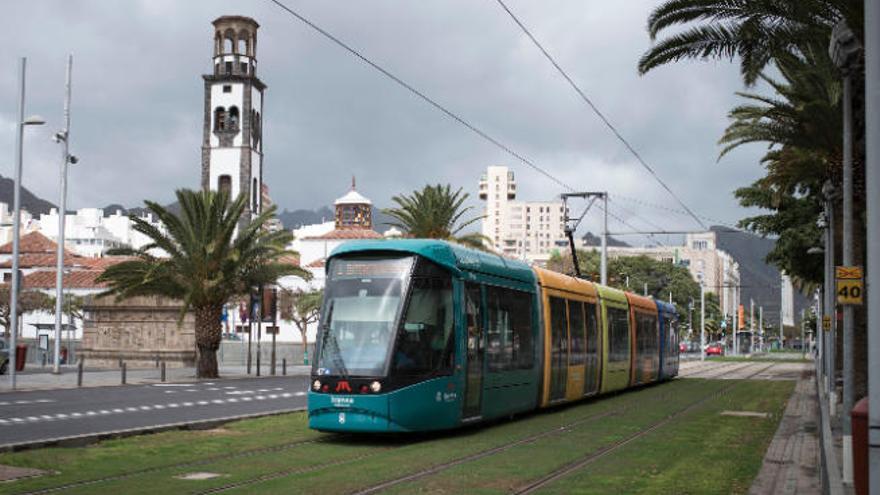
(394, 276, 455, 375)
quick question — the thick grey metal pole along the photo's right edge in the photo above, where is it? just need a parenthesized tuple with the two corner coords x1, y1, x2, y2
(864, 0, 880, 495)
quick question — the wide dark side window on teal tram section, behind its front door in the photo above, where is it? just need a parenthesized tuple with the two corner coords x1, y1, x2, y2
(486, 287, 535, 371)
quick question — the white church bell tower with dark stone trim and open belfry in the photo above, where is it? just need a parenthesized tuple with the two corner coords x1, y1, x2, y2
(202, 16, 266, 225)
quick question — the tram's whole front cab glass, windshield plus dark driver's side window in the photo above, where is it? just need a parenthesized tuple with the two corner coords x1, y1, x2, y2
(315, 256, 455, 378)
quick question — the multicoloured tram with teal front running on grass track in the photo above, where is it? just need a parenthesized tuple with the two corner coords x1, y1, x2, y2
(308, 239, 679, 432)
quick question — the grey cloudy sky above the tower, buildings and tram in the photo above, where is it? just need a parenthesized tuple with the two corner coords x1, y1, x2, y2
(0, 0, 763, 245)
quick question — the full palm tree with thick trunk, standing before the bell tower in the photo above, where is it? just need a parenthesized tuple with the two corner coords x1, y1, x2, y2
(98, 189, 310, 378)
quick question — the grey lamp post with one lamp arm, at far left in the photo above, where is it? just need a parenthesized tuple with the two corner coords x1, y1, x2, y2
(9, 57, 46, 390)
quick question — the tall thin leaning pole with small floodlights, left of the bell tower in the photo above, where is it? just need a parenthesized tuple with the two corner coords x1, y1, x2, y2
(52, 55, 76, 375)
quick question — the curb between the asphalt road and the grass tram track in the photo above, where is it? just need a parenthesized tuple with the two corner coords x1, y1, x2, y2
(0, 407, 307, 452)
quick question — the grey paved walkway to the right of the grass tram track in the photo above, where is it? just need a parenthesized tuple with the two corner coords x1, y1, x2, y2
(749, 368, 822, 495)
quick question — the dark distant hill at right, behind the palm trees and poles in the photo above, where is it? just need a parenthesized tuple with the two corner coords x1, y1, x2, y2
(710, 226, 810, 327)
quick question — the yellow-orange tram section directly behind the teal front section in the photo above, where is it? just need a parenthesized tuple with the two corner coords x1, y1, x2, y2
(534, 268, 602, 407)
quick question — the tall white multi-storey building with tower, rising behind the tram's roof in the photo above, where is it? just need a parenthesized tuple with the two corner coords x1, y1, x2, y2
(480, 166, 568, 262)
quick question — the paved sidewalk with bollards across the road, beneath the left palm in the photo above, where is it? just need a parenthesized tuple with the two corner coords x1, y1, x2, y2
(0, 363, 311, 392)
